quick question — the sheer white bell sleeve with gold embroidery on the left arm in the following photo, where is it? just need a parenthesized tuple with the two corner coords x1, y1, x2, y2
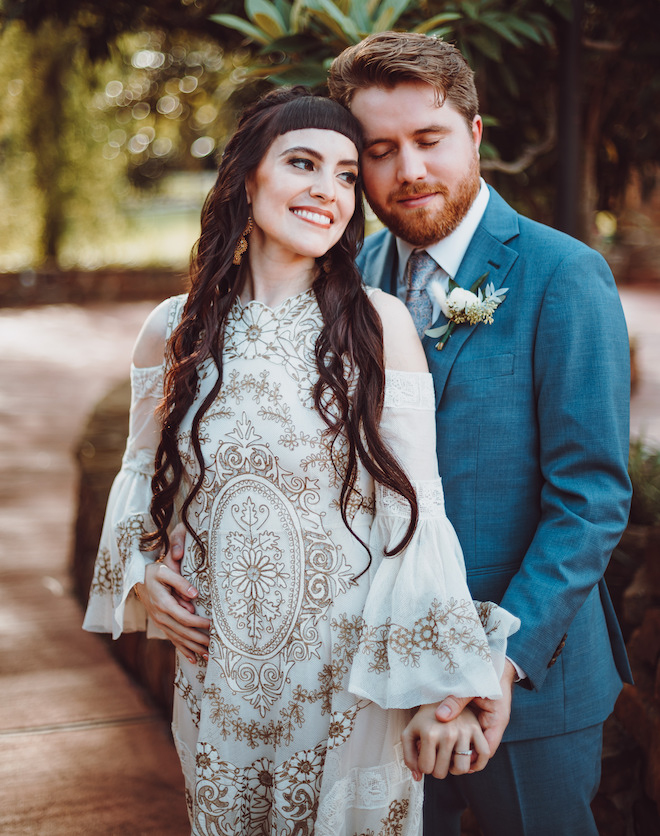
(83, 365, 164, 639)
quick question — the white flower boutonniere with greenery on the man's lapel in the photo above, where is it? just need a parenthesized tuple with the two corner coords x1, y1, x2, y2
(424, 273, 509, 351)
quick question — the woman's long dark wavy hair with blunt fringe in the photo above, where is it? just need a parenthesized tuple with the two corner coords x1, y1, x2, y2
(141, 87, 418, 576)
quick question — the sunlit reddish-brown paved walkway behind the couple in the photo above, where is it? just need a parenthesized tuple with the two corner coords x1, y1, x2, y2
(0, 289, 660, 836)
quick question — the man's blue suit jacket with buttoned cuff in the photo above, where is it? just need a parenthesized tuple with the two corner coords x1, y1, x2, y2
(358, 189, 631, 740)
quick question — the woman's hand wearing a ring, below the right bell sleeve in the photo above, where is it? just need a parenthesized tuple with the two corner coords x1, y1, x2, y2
(401, 703, 490, 781)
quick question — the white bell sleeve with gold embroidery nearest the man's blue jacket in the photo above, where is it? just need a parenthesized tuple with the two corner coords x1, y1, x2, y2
(349, 370, 520, 708)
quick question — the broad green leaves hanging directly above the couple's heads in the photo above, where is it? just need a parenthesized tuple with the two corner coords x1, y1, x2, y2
(210, 0, 569, 92)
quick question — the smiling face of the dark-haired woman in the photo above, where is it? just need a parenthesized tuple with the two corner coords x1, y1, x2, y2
(246, 128, 358, 260)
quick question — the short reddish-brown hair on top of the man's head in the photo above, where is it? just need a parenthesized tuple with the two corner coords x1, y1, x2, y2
(328, 32, 479, 126)
